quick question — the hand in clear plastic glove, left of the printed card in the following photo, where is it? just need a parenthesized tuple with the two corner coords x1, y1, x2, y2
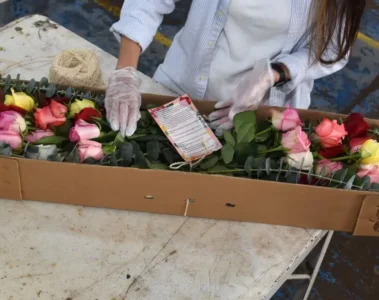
(105, 67, 141, 136)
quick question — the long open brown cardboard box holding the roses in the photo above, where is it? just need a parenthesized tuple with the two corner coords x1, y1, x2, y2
(0, 95, 379, 236)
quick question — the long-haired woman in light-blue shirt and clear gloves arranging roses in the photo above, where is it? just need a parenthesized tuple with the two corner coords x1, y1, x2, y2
(105, 0, 366, 136)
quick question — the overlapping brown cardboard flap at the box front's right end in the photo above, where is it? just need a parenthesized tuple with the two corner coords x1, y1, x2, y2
(353, 196, 379, 237)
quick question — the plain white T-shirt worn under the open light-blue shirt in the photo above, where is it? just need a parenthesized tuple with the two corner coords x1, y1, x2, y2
(205, 0, 292, 101)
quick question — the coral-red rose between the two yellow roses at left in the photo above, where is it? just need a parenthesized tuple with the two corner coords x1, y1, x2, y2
(34, 100, 67, 130)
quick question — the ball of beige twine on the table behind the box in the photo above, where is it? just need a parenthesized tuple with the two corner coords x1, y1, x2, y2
(49, 49, 105, 89)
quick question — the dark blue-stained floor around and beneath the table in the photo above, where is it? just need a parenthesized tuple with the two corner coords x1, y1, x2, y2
(0, 0, 379, 300)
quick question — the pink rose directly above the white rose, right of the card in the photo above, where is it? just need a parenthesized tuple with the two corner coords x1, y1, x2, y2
(282, 126, 311, 154)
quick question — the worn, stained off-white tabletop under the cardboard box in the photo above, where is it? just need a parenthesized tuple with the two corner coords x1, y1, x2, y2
(0, 16, 325, 300)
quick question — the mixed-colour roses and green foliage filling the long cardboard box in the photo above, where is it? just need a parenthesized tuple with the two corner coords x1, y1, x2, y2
(0, 76, 379, 191)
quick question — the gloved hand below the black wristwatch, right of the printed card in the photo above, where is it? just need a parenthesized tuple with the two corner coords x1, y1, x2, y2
(209, 59, 274, 135)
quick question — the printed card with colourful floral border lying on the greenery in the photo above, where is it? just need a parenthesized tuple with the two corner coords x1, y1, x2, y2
(149, 95, 222, 162)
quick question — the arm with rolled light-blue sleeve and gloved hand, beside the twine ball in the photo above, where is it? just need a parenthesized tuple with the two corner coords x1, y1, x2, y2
(104, 0, 180, 136)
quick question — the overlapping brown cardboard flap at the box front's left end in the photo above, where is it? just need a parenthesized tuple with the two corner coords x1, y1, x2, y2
(0, 158, 22, 200)
